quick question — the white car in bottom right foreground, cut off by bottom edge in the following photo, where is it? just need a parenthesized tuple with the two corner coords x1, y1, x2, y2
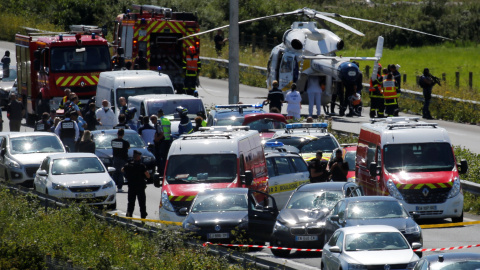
(321, 225, 422, 270)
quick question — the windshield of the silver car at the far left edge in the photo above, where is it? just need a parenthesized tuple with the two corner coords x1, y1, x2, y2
(10, 135, 65, 155)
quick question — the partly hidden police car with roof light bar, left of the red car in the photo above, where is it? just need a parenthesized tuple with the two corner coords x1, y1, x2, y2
(207, 104, 267, 126)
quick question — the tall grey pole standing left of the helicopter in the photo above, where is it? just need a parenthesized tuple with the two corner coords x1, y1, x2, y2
(228, 0, 240, 104)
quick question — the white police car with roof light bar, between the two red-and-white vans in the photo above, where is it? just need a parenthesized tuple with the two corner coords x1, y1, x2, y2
(267, 123, 340, 161)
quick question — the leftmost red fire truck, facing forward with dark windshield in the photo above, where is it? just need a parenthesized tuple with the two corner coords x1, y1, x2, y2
(15, 25, 111, 124)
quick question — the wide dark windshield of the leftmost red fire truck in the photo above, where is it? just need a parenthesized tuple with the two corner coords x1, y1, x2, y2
(50, 45, 110, 73)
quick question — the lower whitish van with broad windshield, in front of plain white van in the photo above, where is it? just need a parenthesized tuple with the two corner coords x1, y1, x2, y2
(128, 94, 205, 137)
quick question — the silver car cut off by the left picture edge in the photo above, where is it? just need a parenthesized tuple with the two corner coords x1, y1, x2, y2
(0, 132, 66, 185)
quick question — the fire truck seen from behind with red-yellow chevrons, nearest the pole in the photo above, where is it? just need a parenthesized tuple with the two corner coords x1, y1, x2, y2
(113, 5, 200, 92)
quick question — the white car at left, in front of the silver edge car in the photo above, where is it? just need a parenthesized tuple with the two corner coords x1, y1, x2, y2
(33, 153, 117, 209)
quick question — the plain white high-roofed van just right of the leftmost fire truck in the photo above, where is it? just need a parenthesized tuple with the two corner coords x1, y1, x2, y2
(95, 70, 174, 117)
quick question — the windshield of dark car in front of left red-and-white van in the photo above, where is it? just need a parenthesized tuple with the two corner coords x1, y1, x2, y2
(192, 193, 248, 212)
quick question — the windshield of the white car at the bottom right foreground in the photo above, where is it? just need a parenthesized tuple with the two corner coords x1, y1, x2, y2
(345, 232, 410, 251)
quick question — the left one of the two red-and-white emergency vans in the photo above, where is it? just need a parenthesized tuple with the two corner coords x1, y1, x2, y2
(159, 126, 268, 222)
